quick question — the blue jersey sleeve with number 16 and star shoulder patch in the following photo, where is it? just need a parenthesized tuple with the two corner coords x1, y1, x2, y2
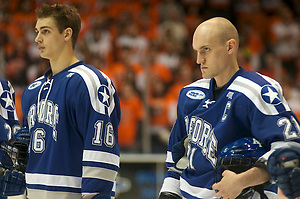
(70, 71, 120, 197)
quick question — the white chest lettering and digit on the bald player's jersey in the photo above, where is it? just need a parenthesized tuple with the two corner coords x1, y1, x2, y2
(185, 116, 218, 169)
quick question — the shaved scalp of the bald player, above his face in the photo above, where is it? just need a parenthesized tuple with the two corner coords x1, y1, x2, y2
(194, 17, 239, 49)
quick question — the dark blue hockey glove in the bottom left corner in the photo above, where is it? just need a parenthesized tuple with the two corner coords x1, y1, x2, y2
(0, 168, 26, 196)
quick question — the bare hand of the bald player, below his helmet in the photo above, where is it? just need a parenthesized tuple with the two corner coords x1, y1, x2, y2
(212, 170, 244, 199)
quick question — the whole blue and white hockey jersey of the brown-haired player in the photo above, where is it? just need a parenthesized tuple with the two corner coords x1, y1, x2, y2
(22, 61, 120, 199)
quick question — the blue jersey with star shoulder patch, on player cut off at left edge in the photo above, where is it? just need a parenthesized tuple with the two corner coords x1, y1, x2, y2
(0, 77, 20, 143)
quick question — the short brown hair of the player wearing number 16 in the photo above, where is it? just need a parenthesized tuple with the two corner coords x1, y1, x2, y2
(35, 3, 81, 48)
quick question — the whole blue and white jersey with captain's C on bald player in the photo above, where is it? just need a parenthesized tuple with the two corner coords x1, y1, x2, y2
(161, 68, 300, 199)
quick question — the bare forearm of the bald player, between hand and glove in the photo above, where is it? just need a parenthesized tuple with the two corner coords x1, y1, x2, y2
(238, 167, 270, 188)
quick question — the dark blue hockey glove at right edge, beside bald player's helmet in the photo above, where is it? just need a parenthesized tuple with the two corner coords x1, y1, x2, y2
(267, 146, 300, 199)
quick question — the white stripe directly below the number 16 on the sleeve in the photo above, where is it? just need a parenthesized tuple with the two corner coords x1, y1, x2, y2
(82, 150, 120, 167)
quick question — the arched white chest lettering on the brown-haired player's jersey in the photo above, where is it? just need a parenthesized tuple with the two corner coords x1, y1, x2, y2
(27, 100, 59, 133)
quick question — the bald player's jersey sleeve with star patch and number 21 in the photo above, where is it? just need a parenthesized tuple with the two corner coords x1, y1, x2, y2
(244, 76, 300, 159)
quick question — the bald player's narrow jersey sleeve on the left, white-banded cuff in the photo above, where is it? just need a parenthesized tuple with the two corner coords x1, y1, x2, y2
(160, 88, 187, 196)
